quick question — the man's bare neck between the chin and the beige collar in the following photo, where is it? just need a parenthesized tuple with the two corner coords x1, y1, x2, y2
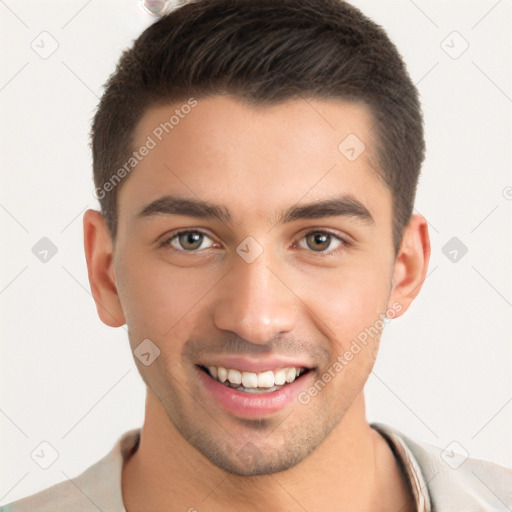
(122, 390, 414, 512)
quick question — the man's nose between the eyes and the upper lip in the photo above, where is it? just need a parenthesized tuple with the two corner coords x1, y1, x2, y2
(214, 247, 299, 344)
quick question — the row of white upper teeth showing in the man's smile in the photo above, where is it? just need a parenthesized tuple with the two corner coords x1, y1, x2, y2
(207, 366, 303, 391)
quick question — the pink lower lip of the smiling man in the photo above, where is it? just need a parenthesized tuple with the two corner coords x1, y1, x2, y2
(196, 367, 313, 418)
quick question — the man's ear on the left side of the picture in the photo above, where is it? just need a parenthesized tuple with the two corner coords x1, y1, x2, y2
(83, 210, 126, 327)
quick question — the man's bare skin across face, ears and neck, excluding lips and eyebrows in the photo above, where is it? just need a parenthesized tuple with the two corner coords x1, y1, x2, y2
(84, 96, 430, 512)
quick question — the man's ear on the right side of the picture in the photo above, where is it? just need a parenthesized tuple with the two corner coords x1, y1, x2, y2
(388, 214, 430, 317)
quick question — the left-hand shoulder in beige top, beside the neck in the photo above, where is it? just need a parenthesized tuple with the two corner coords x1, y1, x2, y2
(0, 429, 140, 512)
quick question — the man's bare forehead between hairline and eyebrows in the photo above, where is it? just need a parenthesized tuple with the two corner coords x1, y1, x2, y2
(119, 96, 391, 230)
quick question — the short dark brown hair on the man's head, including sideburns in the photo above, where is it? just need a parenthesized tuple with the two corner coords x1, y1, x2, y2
(91, 0, 425, 254)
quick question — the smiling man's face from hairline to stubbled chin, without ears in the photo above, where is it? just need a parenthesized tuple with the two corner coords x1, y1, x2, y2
(91, 96, 416, 475)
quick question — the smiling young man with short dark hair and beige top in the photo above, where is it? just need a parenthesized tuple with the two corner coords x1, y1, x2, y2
(3, 0, 512, 512)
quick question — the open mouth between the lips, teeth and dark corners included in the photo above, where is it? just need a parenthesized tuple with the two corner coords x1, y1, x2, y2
(197, 365, 311, 393)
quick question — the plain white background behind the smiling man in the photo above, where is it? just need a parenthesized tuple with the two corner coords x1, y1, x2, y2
(0, 0, 512, 503)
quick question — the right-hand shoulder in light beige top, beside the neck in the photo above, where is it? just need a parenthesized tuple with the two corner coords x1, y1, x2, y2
(372, 423, 512, 512)
